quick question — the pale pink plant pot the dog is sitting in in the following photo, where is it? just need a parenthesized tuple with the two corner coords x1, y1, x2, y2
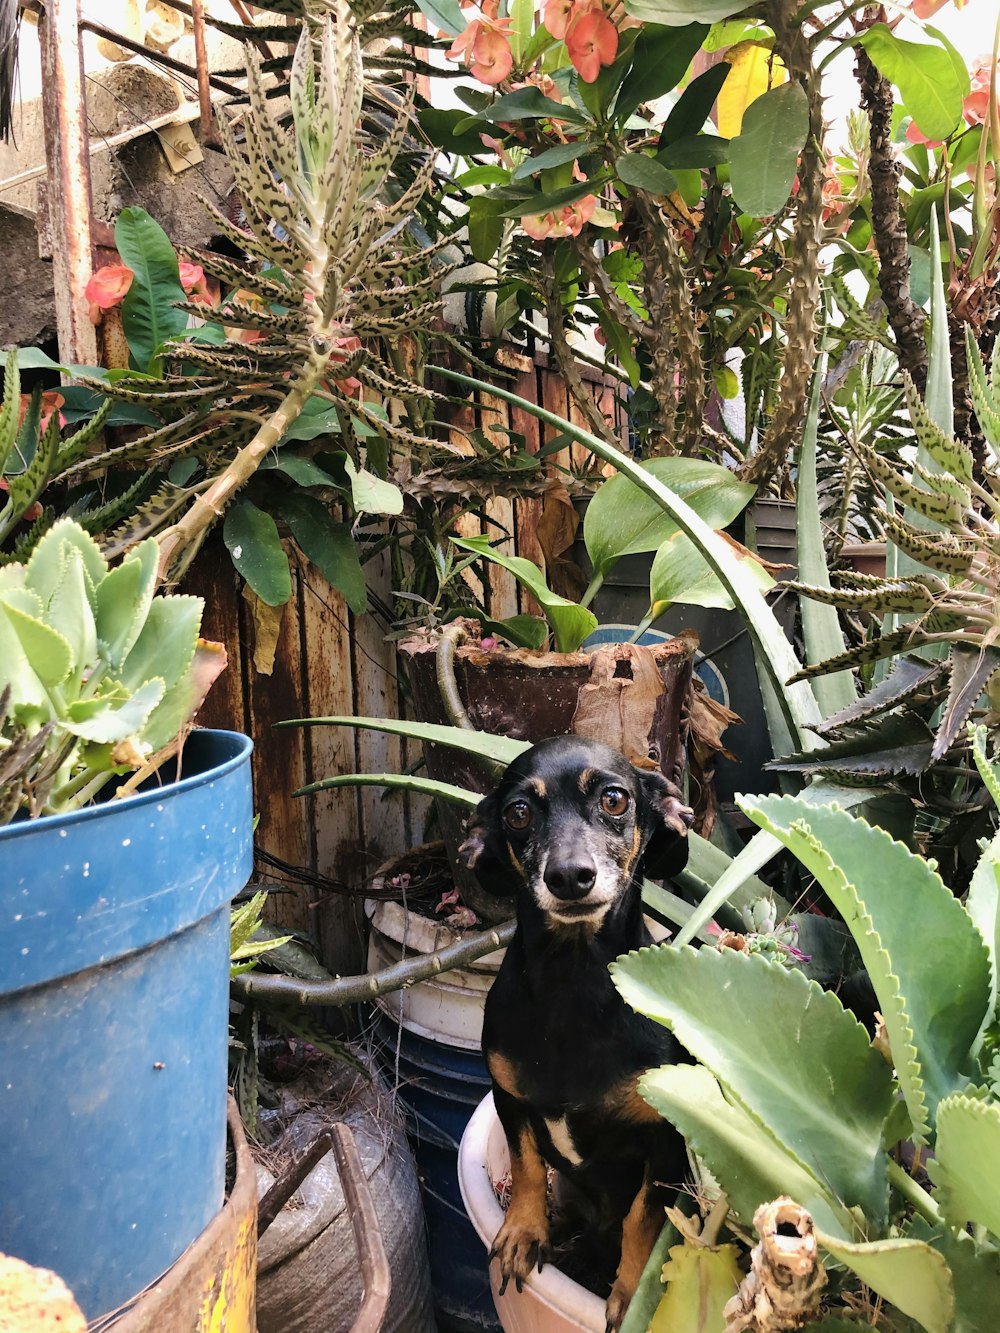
(459, 1093, 605, 1333)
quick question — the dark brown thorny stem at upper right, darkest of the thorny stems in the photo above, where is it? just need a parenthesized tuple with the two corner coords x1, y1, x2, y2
(855, 32, 927, 392)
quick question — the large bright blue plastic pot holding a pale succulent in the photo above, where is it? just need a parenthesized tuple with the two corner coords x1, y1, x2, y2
(0, 730, 252, 1318)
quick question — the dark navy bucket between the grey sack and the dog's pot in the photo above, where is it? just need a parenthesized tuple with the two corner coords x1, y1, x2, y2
(376, 1013, 500, 1333)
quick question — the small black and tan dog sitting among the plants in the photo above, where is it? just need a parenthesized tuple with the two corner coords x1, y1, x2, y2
(463, 736, 691, 1329)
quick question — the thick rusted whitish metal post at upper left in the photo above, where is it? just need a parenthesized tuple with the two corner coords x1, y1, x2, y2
(39, 0, 97, 365)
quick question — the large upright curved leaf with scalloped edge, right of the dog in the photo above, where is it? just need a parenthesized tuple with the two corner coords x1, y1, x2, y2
(740, 796, 989, 1142)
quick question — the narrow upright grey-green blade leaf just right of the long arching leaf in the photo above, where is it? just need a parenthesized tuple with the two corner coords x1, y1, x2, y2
(795, 361, 857, 717)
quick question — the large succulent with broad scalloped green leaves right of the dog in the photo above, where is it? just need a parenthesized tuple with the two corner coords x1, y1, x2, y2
(612, 729, 1000, 1333)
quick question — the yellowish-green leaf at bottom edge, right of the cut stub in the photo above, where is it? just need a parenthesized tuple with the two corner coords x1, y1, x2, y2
(817, 1232, 955, 1333)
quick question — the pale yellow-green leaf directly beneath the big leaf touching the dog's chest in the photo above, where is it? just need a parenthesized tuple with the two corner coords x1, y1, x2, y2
(639, 1065, 855, 1240)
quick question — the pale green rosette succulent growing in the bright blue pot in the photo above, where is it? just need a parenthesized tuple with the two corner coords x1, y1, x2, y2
(0, 519, 225, 822)
